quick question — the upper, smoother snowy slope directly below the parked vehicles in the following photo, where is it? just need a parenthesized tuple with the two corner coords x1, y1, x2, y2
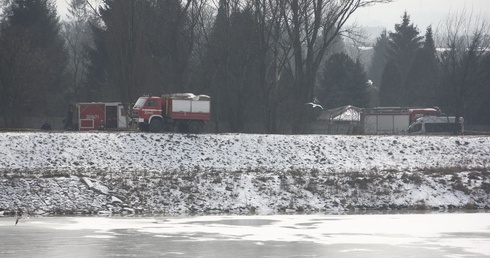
(0, 133, 490, 172)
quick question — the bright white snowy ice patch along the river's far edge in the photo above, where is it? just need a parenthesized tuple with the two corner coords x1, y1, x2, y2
(58, 213, 490, 255)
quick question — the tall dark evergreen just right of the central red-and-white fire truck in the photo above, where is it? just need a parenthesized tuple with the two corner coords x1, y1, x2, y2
(207, 1, 265, 132)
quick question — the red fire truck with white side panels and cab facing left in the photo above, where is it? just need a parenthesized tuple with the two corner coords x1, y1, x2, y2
(132, 93, 211, 133)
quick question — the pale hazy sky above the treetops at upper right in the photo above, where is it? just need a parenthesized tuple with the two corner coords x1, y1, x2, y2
(353, 0, 490, 31)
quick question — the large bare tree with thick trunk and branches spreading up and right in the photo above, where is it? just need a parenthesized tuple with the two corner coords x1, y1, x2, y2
(283, 0, 392, 133)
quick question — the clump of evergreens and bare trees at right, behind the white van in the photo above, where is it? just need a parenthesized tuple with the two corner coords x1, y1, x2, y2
(369, 10, 490, 125)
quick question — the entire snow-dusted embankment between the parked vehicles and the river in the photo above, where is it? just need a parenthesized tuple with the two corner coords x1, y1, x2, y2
(0, 132, 490, 214)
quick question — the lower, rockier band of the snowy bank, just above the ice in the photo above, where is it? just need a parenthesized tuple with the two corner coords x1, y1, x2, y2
(0, 168, 490, 216)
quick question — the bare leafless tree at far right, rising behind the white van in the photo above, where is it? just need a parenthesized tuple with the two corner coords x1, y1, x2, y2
(439, 10, 490, 126)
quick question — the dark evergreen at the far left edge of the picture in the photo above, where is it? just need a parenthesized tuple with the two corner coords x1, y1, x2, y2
(0, 0, 67, 126)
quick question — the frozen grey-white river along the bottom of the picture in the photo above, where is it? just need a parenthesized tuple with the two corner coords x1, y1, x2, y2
(0, 213, 490, 258)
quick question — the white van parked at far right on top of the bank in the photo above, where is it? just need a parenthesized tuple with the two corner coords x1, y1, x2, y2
(407, 116, 464, 135)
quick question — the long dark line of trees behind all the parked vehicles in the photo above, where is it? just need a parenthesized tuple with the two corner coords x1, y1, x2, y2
(0, 0, 490, 133)
